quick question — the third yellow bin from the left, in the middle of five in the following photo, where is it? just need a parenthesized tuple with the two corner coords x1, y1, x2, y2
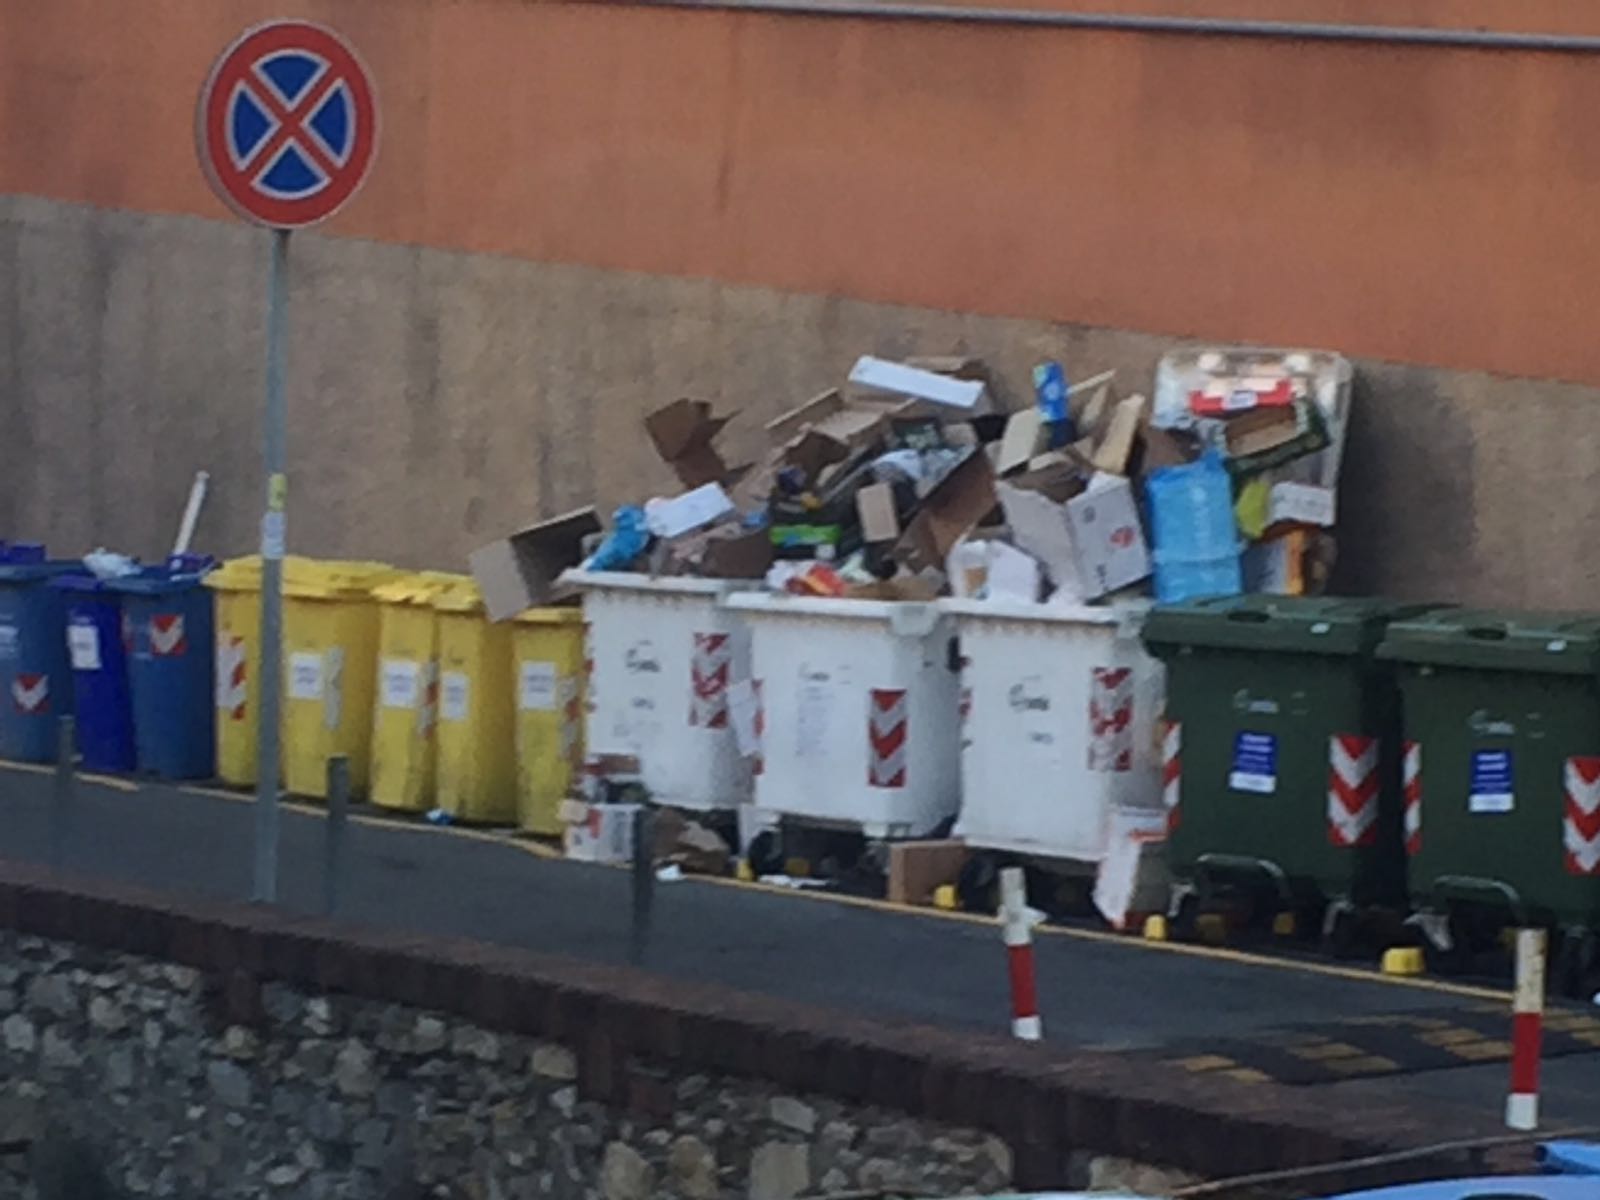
(371, 571, 467, 813)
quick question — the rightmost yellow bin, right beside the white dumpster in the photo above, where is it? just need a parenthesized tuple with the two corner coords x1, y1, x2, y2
(512, 608, 584, 837)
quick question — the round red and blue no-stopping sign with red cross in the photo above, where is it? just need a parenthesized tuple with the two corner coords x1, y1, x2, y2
(195, 21, 378, 229)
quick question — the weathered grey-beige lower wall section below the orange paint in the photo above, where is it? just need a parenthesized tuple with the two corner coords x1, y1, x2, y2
(0, 198, 1600, 606)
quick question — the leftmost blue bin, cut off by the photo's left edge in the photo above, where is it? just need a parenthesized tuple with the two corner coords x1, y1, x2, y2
(0, 542, 83, 763)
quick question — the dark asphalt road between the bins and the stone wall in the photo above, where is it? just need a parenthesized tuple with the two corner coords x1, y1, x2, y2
(0, 766, 1600, 1120)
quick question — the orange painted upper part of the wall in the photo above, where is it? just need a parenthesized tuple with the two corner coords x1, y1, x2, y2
(0, 0, 1600, 382)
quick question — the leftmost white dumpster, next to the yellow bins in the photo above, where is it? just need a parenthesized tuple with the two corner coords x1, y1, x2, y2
(562, 571, 752, 813)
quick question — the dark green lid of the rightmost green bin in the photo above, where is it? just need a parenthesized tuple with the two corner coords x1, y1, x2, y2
(1378, 608, 1600, 675)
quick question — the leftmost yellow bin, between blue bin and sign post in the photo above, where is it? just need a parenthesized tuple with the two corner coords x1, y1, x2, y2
(205, 555, 261, 787)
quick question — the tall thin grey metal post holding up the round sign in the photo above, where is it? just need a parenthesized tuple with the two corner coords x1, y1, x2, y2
(251, 229, 290, 904)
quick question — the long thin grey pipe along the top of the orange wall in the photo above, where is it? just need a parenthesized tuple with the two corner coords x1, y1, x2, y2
(627, 0, 1600, 54)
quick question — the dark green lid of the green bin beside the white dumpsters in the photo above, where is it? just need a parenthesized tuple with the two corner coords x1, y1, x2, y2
(1144, 595, 1434, 654)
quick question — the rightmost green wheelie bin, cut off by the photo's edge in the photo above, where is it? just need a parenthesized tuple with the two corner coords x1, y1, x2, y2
(1379, 610, 1600, 997)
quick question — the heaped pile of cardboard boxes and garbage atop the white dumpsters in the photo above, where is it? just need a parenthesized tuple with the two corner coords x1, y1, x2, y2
(474, 347, 1350, 614)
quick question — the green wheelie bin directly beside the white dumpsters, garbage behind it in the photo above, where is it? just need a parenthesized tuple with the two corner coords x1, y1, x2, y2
(1144, 595, 1422, 952)
